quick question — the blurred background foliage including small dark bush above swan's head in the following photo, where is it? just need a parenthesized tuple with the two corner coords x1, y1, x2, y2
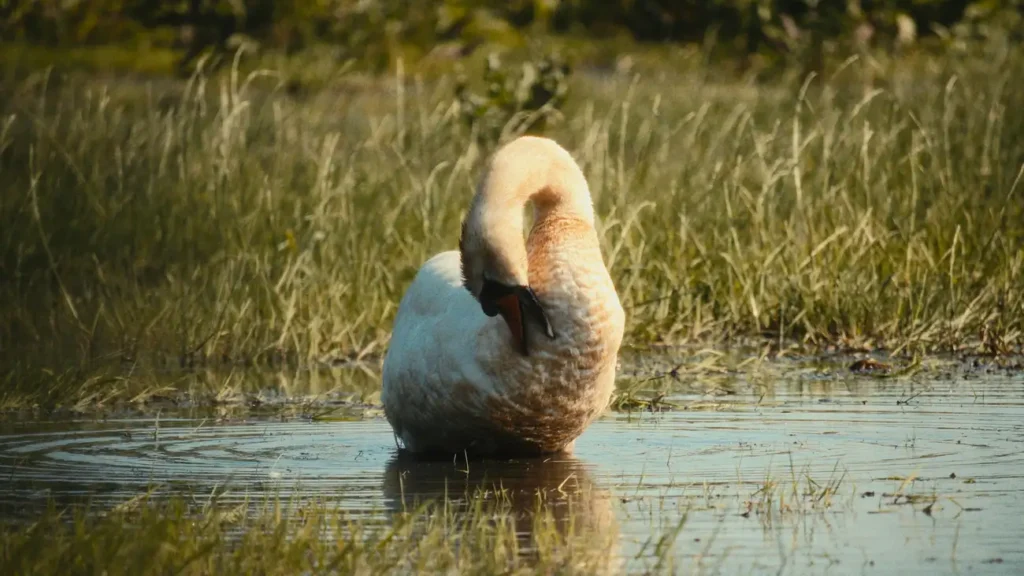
(0, 0, 1024, 156)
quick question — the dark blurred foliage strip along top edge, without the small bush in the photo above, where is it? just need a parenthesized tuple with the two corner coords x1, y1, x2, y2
(0, 0, 1024, 72)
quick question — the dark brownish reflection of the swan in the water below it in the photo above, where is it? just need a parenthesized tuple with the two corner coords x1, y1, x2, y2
(384, 452, 618, 573)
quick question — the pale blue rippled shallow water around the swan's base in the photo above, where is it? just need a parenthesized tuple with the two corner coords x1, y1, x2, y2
(0, 364, 1024, 574)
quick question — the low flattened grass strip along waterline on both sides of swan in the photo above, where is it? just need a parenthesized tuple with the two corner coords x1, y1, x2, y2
(0, 336, 1024, 412)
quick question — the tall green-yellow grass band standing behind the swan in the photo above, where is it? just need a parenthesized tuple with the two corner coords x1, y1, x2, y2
(0, 48, 1024, 399)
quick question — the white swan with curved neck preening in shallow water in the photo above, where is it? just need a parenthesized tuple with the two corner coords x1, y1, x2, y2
(381, 136, 626, 457)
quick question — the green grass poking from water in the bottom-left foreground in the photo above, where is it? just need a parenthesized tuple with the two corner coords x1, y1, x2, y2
(0, 487, 615, 574)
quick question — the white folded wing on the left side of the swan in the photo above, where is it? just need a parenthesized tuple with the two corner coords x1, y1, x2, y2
(381, 251, 489, 449)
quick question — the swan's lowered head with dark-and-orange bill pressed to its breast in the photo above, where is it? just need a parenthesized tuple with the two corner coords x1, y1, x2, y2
(459, 199, 555, 356)
